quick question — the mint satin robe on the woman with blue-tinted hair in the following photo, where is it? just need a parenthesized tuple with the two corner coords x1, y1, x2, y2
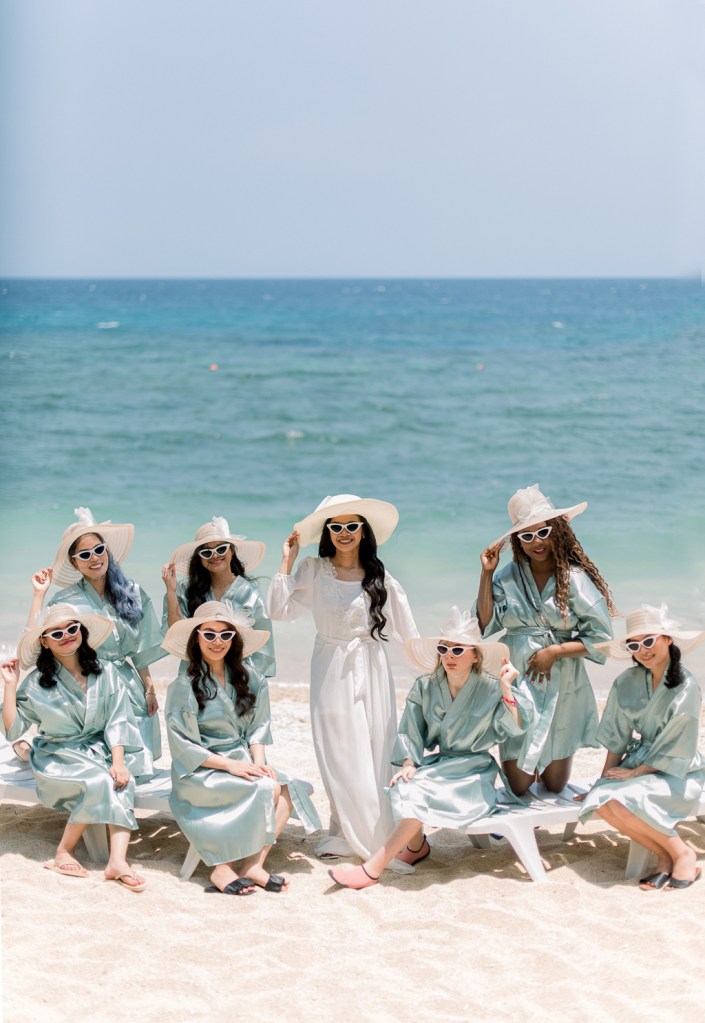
(49, 579, 167, 774)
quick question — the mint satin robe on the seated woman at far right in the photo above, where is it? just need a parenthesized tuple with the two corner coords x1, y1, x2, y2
(580, 665, 705, 835)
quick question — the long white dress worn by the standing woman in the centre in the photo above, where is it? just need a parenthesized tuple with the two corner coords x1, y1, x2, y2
(266, 558, 418, 859)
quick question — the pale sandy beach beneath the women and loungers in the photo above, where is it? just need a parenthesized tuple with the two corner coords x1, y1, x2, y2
(0, 682, 705, 1023)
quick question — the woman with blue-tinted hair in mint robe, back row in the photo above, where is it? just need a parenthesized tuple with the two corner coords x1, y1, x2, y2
(30, 508, 165, 774)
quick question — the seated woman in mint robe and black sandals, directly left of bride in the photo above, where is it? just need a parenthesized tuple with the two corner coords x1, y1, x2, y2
(164, 601, 320, 895)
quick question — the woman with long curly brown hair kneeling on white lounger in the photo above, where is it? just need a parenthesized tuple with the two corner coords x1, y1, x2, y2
(476, 484, 616, 796)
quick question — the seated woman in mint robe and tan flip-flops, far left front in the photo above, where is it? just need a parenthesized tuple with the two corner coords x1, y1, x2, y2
(1, 604, 144, 892)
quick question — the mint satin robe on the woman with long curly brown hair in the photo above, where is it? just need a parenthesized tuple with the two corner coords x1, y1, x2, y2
(484, 562, 612, 773)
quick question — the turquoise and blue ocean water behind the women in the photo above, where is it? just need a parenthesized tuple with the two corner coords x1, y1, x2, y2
(0, 279, 705, 678)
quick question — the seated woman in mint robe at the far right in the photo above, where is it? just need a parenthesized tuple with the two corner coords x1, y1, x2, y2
(580, 605, 705, 891)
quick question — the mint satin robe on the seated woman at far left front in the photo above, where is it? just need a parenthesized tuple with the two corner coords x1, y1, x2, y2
(3, 663, 144, 831)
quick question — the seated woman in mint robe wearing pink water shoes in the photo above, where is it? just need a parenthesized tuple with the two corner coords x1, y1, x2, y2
(328, 608, 532, 888)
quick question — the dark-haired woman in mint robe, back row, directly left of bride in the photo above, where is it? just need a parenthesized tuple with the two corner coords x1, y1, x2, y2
(162, 516, 276, 677)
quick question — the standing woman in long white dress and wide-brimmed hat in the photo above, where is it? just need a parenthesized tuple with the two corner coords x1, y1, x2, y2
(267, 494, 418, 870)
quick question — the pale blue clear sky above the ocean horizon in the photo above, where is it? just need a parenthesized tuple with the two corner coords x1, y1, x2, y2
(0, 0, 705, 277)
